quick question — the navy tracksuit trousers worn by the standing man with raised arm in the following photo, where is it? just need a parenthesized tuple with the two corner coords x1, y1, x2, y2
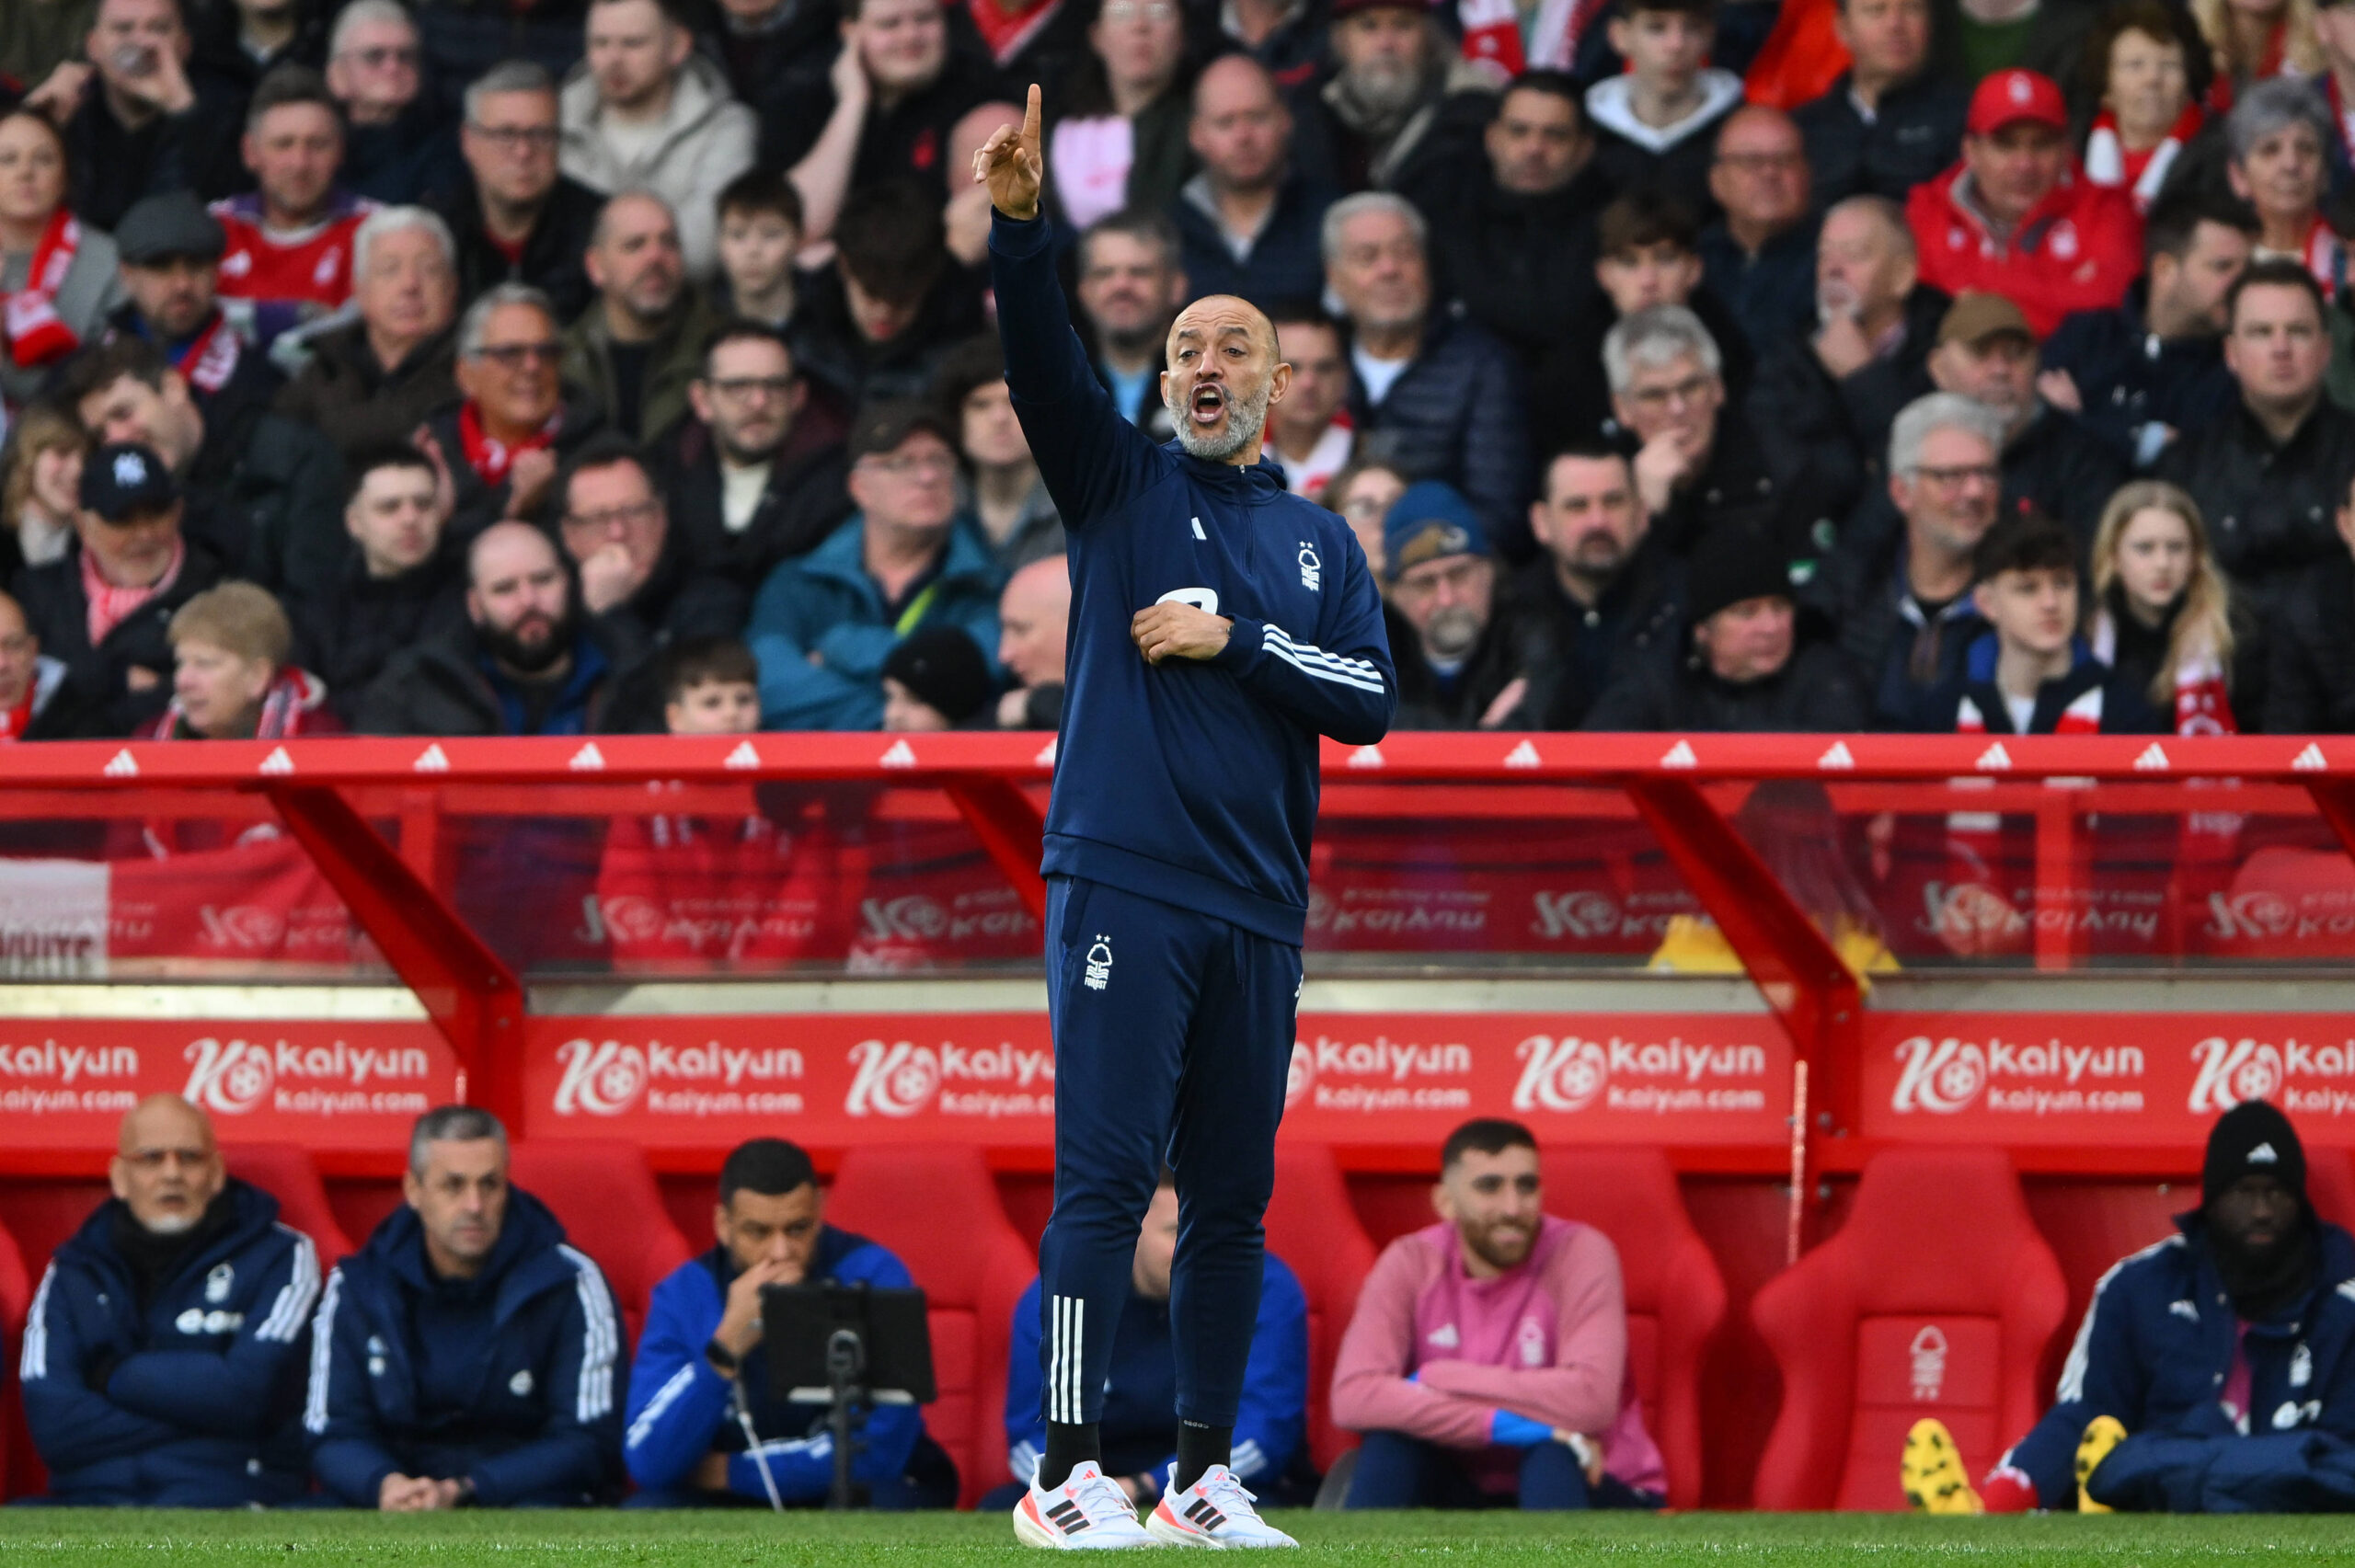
(1039, 878, 1300, 1426)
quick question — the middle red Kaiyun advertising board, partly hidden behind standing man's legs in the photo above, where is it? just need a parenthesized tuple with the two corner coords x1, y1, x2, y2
(525, 1013, 1790, 1149)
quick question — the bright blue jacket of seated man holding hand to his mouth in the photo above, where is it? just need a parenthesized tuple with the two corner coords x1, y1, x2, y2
(622, 1224, 924, 1502)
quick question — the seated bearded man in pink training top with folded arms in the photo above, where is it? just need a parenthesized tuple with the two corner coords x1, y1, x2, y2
(1333, 1121, 1667, 1509)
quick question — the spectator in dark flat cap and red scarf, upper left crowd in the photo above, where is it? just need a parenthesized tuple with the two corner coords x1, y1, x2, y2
(106, 190, 285, 426)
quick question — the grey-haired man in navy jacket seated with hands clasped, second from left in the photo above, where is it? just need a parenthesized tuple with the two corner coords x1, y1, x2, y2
(304, 1104, 622, 1512)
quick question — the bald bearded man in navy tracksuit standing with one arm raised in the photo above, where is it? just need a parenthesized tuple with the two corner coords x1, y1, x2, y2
(972, 87, 1399, 1550)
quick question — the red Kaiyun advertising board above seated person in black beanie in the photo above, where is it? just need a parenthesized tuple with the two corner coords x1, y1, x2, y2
(1860, 1013, 2355, 1147)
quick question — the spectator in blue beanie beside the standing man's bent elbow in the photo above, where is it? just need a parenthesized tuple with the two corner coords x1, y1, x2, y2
(1383, 480, 1528, 730)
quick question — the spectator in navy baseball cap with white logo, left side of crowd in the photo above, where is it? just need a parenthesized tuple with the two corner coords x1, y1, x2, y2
(17, 442, 222, 737)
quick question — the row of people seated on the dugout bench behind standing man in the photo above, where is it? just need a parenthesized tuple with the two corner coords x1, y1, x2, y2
(18, 1094, 2355, 1514)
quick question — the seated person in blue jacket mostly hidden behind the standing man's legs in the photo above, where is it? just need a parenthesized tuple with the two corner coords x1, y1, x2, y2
(982, 1170, 1309, 1506)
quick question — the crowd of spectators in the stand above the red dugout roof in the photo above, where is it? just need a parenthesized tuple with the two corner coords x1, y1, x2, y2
(0, 0, 2355, 739)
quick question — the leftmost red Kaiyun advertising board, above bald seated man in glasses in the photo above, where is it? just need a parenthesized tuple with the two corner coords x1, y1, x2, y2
(0, 1017, 459, 1149)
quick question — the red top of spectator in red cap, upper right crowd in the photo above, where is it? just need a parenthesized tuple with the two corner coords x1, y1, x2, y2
(1905, 163, 2143, 339)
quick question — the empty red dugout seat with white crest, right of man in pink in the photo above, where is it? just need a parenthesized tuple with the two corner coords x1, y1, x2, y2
(1750, 1149, 2068, 1509)
